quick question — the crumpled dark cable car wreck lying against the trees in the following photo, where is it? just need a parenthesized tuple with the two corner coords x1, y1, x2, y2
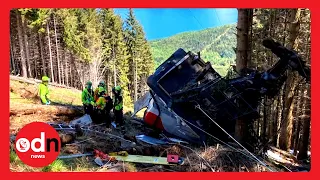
(133, 39, 310, 144)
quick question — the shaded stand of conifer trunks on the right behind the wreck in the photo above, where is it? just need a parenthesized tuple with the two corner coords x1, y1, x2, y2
(236, 9, 311, 160)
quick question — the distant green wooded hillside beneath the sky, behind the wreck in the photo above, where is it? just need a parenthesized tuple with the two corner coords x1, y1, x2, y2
(150, 24, 236, 75)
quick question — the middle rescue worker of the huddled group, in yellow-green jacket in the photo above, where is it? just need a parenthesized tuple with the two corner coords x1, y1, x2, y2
(93, 86, 112, 128)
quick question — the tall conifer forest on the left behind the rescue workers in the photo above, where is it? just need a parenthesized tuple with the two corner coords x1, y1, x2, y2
(10, 9, 154, 105)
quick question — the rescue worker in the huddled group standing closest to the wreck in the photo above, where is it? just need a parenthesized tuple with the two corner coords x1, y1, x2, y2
(112, 86, 123, 126)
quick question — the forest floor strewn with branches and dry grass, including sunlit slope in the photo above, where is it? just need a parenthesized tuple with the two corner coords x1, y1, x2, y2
(10, 80, 308, 172)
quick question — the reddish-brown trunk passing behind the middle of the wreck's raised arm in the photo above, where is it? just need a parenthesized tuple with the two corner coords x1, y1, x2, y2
(279, 9, 300, 150)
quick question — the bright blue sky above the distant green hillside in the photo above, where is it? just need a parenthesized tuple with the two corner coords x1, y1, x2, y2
(115, 8, 238, 40)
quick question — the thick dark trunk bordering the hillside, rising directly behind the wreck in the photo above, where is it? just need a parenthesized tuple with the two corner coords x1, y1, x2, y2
(235, 9, 252, 144)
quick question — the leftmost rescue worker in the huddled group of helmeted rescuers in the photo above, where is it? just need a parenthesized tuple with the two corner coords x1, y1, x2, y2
(81, 81, 94, 115)
